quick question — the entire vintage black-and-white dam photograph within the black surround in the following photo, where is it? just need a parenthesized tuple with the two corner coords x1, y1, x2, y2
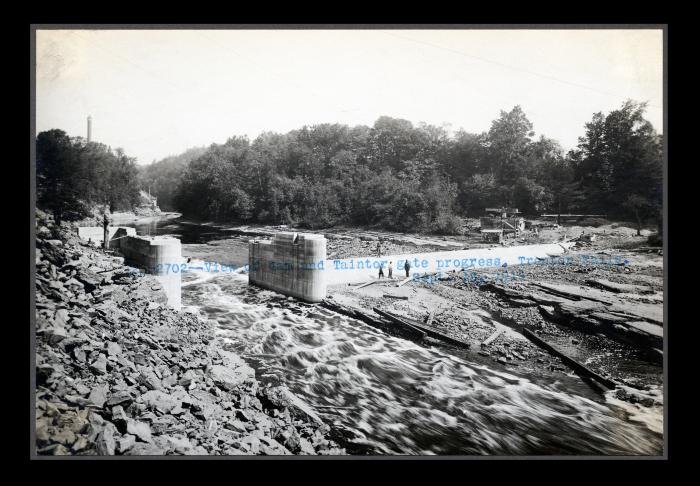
(30, 24, 668, 460)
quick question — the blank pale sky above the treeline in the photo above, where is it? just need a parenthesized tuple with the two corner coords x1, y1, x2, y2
(36, 29, 663, 164)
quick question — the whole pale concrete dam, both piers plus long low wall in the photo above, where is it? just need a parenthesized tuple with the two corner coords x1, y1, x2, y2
(79, 227, 572, 309)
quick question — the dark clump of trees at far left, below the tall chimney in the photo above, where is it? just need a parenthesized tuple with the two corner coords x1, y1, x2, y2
(36, 129, 139, 222)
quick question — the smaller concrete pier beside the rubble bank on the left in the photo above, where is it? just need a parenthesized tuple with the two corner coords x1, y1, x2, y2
(118, 236, 182, 310)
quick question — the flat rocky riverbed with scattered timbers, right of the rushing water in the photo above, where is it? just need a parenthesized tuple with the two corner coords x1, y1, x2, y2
(328, 224, 664, 398)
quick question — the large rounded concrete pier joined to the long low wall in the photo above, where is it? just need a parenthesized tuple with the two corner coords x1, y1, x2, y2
(248, 232, 326, 302)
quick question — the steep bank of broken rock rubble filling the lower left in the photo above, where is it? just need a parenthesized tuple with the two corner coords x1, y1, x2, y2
(35, 212, 345, 455)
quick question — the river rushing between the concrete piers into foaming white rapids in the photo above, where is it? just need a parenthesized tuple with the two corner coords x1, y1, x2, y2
(138, 220, 663, 455)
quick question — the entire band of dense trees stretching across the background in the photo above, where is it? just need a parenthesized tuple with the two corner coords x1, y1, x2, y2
(37, 101, 663, 234)
